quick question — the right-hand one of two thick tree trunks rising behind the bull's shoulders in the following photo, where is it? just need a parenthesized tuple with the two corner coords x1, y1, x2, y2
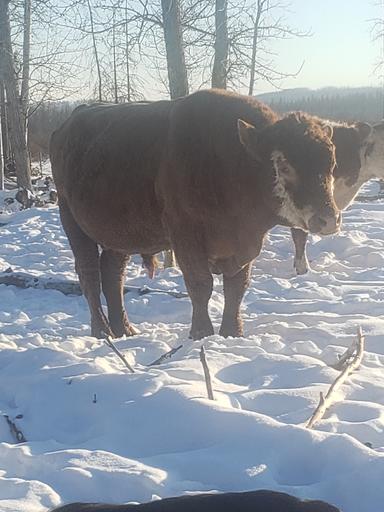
(212, 0, 229, 89)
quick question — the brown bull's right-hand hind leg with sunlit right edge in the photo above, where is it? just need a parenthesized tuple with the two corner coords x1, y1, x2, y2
(100, 249, 138, 338)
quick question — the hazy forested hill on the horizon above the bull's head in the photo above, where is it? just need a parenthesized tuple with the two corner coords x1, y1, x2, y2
(257, 87, 384, 122)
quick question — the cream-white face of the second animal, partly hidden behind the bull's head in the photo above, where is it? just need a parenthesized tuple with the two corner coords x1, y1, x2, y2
(334, 124, 384, 210)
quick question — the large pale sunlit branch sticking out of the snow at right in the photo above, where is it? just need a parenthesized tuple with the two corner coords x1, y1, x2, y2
(306, 327, 365, 428)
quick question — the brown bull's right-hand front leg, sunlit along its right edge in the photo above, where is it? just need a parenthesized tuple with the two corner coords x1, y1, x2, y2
(219, 263, 252, 337)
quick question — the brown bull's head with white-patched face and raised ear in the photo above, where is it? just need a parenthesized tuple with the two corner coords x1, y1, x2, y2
(238, 113, 341, 235)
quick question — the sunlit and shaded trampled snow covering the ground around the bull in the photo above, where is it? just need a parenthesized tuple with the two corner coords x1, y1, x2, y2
(0, 184, 384, 512)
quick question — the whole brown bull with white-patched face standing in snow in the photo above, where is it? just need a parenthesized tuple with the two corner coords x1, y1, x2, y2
(50, 90, 340, 339)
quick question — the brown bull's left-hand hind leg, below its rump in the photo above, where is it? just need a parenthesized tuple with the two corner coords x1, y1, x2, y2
(59, 198, 113, 338)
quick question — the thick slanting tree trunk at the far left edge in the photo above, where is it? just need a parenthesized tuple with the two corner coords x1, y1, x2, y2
(0, 0, 32, 190)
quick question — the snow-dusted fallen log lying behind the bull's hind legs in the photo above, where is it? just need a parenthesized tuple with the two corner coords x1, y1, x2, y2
(0, 269, 188, 299)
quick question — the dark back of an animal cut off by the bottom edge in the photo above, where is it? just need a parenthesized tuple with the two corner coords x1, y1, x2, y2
(52, 491, 341, 512)
